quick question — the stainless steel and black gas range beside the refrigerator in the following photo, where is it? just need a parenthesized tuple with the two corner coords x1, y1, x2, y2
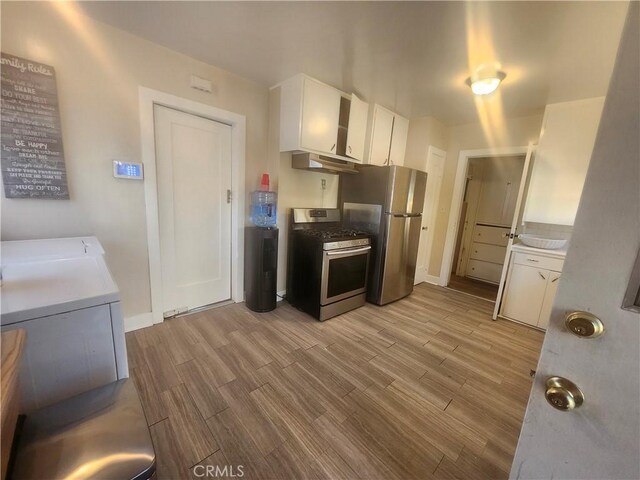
(287, 208, 371, 320)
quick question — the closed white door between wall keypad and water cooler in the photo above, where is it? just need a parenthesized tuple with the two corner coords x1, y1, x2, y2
(154, 105, 231, 317)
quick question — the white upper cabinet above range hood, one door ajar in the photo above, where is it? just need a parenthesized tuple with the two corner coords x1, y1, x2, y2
(280, 74, 369, 162)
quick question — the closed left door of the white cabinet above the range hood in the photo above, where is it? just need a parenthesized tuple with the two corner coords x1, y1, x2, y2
(300, 78, 340, 153)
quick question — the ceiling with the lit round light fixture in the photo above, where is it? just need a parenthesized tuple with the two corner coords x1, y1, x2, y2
(81, 1, 627, 124)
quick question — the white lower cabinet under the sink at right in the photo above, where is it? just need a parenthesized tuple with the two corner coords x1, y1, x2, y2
(500, 254, 562, 329)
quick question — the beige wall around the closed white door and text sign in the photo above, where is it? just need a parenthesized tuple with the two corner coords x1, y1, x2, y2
(2, 2, 270, 317)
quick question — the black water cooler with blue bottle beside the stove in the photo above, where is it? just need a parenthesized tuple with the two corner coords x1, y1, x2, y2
(244, 174, 278, 312)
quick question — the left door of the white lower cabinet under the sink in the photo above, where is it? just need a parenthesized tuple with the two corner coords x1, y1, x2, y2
(502, 264, 549, 325)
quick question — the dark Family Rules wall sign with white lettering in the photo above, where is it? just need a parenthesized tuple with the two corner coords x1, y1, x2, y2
(0, 53, 69, 199)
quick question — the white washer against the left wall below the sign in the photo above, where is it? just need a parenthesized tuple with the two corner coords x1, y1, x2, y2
(0, 237, 129, 413)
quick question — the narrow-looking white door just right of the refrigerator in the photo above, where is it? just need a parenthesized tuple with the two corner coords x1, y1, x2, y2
(415, 146, 447, 285)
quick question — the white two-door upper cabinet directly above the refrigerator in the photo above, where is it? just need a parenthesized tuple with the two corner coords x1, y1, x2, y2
(369, 105, 409, 165)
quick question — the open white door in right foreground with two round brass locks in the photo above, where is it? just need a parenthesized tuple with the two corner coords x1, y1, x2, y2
(510, 8, 640, 480)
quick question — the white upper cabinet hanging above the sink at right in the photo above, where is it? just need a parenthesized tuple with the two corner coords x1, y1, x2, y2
(524, 97, 604, 225)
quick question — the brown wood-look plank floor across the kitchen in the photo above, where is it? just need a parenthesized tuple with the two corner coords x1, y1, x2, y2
(127, 284, 543, 480)
